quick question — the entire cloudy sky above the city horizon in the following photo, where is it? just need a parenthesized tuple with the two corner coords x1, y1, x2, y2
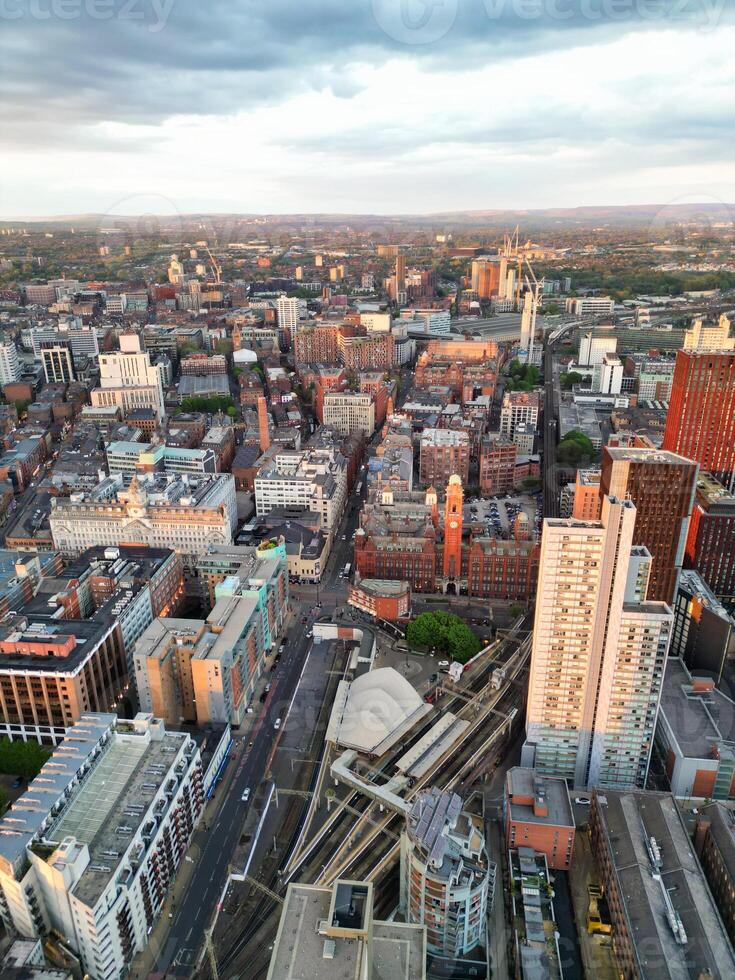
(0, 0, 735, 217)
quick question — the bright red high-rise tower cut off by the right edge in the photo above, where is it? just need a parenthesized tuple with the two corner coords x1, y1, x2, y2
(663, 350, 735, 490)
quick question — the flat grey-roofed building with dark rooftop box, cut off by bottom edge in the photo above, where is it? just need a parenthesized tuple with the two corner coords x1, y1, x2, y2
(266, 878, 426, 980)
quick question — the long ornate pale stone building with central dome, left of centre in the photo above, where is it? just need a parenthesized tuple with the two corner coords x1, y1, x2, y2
(49, 473, 237, 569)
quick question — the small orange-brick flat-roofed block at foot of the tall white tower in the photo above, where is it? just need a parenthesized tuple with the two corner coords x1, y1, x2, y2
(503, 766, 575, 871)
